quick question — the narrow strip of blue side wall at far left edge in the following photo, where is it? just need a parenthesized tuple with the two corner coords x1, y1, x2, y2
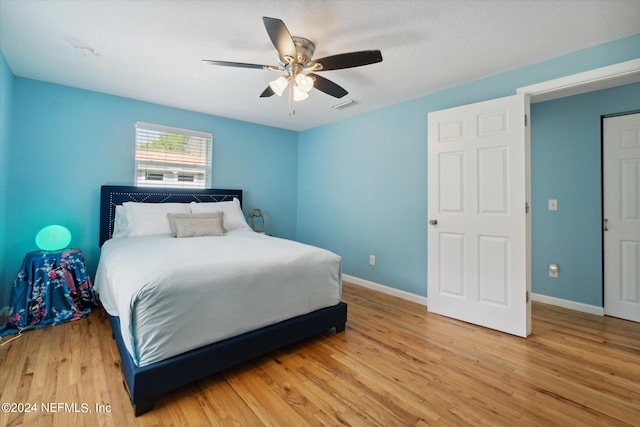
(0, 52, 13, 309)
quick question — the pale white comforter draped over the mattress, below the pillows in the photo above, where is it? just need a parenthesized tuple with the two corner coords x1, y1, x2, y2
(94, 230, 342, 366)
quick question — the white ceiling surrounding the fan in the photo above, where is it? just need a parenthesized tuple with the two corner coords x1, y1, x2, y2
(0, 0, 640, 131)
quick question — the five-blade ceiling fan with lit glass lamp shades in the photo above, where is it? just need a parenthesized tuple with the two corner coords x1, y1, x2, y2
(202, 16, 382, 116)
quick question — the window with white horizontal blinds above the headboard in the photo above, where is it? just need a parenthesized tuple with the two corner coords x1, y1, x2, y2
(136, 122, 213, 188)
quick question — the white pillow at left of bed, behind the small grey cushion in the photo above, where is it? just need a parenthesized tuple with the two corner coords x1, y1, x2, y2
(122, 202, 190, 236)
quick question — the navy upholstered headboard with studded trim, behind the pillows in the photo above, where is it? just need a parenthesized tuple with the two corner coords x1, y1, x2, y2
(100, 185, 242, 247)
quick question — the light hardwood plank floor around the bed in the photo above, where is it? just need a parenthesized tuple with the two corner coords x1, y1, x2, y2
(0, 283, 640, 427)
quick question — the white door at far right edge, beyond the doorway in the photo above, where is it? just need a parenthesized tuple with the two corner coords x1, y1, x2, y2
(603, 113, 640, 322)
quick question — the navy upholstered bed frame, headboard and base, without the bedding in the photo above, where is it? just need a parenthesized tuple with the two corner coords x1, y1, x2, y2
(100, 185, 347, 417)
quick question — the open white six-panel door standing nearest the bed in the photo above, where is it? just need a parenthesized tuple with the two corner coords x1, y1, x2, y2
(427, 94, 531, 337)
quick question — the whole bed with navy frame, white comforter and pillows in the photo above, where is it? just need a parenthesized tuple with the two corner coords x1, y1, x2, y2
(94, 186, 347, 416)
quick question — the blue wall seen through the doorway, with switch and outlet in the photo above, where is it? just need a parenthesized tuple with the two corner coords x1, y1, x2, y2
(531, 83, 640, 306)
